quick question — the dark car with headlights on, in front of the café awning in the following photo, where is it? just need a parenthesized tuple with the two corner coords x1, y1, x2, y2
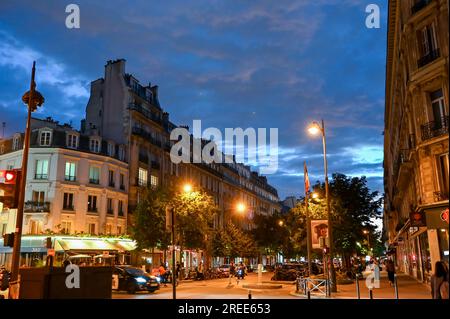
(113, 266, 160, 294)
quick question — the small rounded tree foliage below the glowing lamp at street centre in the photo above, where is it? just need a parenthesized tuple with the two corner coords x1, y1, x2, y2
(212, 221, 258, 258)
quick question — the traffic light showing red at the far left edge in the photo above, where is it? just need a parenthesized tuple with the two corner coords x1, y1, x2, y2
(0, 169, 21, 209)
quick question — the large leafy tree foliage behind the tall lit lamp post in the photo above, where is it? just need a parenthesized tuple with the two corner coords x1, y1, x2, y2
(287, 173, 382, 267)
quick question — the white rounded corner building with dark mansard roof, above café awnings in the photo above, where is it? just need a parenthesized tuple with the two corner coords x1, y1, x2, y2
(0, 118, 129, 235)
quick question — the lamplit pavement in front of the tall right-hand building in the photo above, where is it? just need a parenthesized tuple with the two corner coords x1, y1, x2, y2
(291, 271, 431, 299)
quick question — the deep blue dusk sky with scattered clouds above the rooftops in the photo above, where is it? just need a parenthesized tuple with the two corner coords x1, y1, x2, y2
(0, 0, 387, 198)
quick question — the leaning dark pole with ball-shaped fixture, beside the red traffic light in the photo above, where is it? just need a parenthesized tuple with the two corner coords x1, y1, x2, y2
(9, 61, 44, 298)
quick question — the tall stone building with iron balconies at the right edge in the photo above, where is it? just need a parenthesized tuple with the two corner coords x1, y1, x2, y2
(384, 0, 449, 282)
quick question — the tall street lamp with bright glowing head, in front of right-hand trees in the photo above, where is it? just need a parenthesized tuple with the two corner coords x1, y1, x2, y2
(308, 120, 337, 292)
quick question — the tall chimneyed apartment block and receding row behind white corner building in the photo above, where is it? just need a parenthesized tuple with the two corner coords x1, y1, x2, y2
(82, 59, 281, 231)
